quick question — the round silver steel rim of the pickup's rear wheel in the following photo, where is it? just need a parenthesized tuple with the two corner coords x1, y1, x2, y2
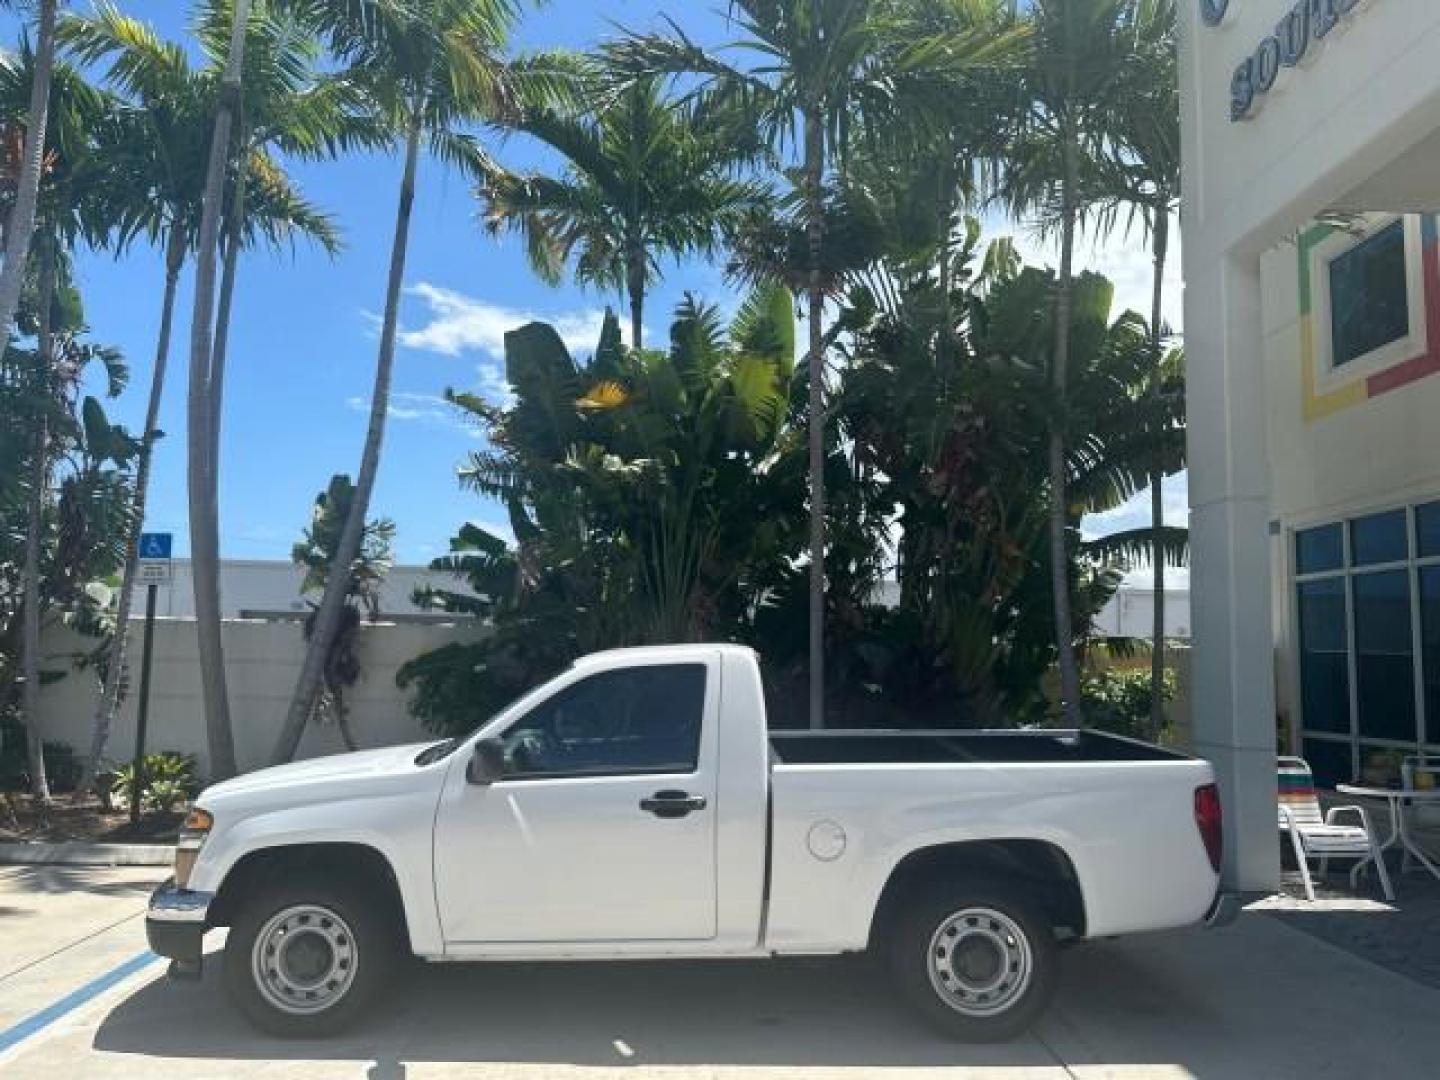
(926, 907, 1034, 1017)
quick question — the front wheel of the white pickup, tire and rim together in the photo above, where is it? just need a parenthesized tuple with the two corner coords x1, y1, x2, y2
(223, 877, 400, 1038)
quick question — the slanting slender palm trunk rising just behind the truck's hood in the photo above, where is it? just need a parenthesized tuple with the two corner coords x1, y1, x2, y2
(271, 112, 423, 765)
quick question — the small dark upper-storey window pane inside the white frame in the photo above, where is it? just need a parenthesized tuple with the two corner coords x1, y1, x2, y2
(1331, 220, 1410, 367)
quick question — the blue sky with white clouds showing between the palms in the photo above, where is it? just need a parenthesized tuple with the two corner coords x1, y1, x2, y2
(0, 0, 1184, 576)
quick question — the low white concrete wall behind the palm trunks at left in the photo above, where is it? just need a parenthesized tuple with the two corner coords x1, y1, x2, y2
(28, 619, 481, 775)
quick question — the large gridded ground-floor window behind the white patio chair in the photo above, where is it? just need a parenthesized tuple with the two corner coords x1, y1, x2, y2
(1295, 503, 1440, 786)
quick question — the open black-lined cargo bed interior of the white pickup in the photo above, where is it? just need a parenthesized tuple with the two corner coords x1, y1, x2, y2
(770, 729, 1185, 765)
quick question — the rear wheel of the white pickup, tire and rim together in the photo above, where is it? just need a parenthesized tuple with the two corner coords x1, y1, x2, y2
(886, 877, 1058, 1043)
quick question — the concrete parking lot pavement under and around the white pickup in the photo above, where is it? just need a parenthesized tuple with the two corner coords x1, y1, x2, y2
(0, 867, 1440, 1080)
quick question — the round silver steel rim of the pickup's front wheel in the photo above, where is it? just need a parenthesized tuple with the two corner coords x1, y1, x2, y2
(251, 904, 359, 1015)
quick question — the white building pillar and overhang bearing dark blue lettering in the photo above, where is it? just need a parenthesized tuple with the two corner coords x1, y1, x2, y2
(1178, 0, 1440, 891)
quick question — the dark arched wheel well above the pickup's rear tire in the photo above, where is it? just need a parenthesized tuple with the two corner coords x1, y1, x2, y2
(870, 840, 1086, 943)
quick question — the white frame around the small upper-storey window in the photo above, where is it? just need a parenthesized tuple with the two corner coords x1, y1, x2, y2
(1309, 215, 1430, 395)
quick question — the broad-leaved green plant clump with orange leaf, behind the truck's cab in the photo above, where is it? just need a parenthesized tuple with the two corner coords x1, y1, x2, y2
(397, 287, 804, 730)
